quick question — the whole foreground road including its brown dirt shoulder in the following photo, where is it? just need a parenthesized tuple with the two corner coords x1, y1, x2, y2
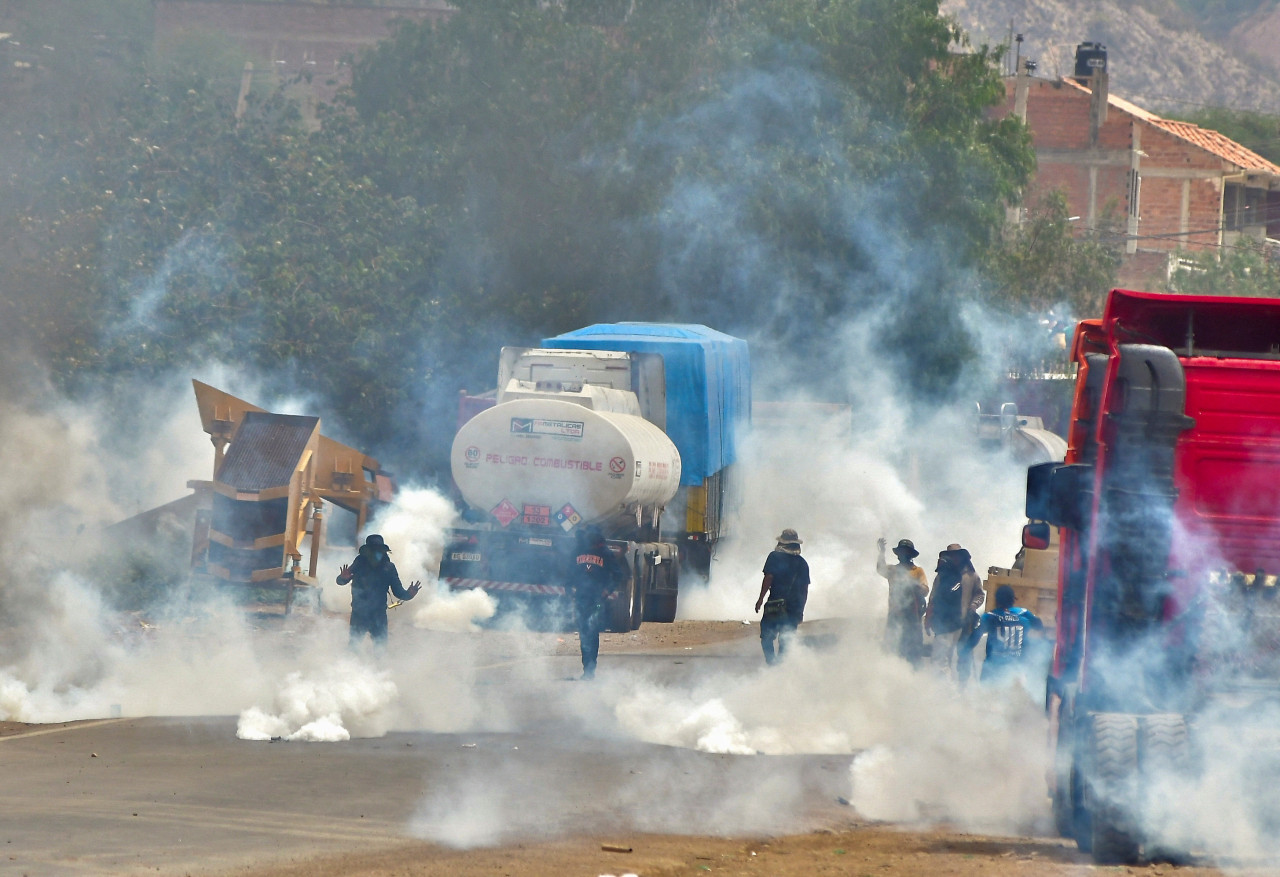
(0, 622, 1259, 877)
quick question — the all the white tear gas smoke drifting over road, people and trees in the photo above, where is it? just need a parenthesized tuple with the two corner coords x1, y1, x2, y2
(10, 24, 1277, 865)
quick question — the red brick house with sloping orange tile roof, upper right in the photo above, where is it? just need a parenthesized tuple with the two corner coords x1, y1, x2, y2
(1001, 44, 1280, 289)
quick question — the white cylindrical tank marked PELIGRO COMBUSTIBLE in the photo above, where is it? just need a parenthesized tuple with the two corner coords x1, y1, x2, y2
(451, 399, 680, 531)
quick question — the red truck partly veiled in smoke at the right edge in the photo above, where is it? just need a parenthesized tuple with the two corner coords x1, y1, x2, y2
(1023, 289, 1280, 863)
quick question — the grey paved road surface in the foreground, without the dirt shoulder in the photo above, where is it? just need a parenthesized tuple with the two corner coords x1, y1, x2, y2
(0, 624, 849, 874)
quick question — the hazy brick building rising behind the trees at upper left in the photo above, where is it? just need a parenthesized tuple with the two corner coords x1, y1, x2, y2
(154, 0, 451, 118)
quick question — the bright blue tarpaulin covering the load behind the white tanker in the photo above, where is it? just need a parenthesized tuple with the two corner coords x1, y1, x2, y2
(543, 323, 751, 485)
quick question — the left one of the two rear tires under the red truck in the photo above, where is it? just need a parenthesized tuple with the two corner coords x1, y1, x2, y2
(1076, 713, 1142, 864)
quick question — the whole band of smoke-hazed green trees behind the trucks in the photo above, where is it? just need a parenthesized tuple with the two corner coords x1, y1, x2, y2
(0, 0, 1044, 469)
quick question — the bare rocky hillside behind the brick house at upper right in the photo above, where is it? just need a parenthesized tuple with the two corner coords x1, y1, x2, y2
(943, 0, 1280, 114)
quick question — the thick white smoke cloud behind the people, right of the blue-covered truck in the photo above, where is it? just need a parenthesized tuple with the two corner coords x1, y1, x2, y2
(678, 389, 1027, 620)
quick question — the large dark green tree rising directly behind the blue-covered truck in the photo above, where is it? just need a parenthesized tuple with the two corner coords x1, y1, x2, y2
(344, 0, 1032, 404)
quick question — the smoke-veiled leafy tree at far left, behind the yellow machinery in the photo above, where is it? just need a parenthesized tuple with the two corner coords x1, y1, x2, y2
(0, 13, 438, 443)
